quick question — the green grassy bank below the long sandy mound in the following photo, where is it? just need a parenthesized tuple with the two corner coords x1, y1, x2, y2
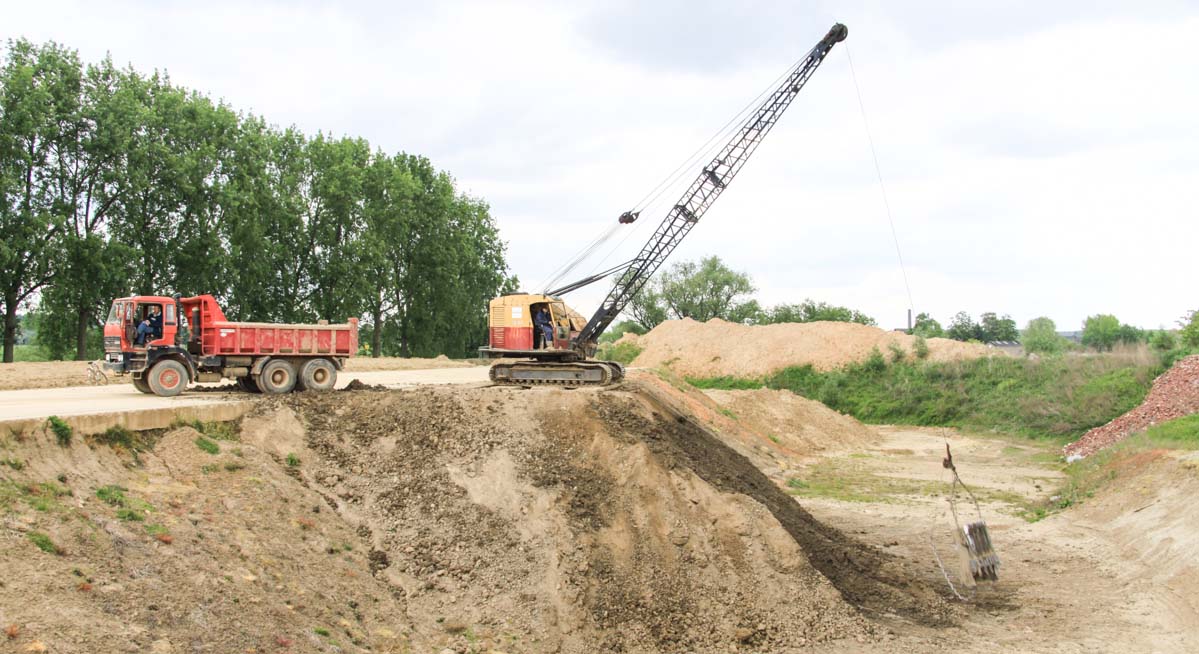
(688, 354, 1162, 438)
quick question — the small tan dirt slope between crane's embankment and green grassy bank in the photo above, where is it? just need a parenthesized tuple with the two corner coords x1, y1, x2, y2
(705, 389, 879, 455)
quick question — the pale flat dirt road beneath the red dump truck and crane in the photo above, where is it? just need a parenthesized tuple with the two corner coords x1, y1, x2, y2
(0, 366, 487, 426)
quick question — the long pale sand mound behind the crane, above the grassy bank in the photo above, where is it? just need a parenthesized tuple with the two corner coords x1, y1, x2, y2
(633, 318, 994, 377)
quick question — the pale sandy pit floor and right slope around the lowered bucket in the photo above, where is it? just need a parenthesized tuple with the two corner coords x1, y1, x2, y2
(800, 428, 1199, 654)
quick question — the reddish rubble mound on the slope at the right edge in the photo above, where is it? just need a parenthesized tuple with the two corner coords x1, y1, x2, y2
(1065, 354, 1199, 456)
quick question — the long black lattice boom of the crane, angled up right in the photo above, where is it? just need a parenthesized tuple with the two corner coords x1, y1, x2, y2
(572, 23, 849, 355)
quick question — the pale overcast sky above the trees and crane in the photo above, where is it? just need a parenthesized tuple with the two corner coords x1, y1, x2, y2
(0, 0, 1199, 330)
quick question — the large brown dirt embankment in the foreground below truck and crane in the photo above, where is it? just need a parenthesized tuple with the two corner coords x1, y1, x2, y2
(0, 383, 950, 653)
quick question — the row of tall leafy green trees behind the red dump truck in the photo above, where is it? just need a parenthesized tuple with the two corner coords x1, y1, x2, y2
(0, 40, 516, 362)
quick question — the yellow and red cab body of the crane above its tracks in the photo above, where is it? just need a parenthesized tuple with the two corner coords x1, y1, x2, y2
(480, 293, 586, 359)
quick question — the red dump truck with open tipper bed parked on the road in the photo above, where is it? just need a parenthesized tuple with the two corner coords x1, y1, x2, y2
(104, 295, 359, 397)
